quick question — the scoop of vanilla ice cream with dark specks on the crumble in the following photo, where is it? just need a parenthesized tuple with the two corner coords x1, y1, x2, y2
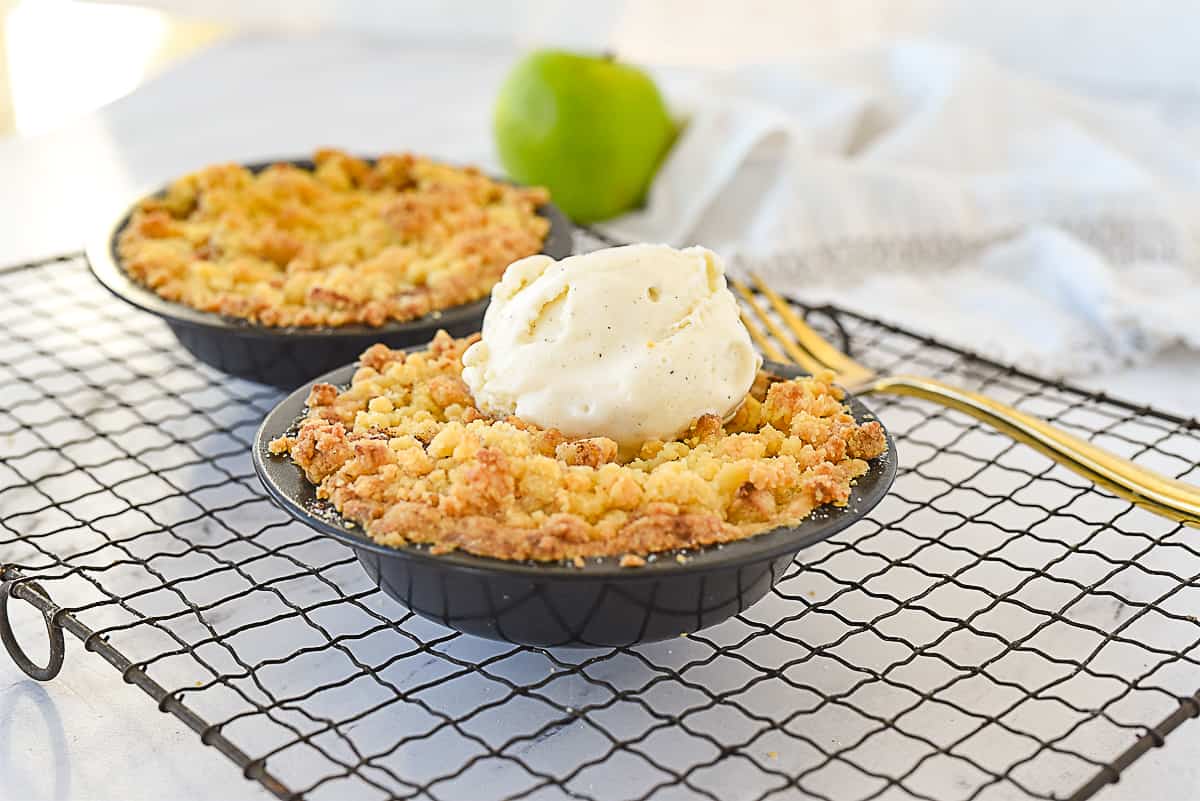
(462, 245, 762, 447)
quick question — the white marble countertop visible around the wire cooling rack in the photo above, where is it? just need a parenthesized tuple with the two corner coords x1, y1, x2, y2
(0, 28, 1200, 801)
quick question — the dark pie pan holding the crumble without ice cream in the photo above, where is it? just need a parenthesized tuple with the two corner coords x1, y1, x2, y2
(86, 158, 574, 389)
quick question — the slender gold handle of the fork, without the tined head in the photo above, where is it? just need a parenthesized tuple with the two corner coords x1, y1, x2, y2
(859, 375, 1200, 526)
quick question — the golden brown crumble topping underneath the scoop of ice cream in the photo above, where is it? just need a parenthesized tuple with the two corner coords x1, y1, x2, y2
(270, 332, 887, 566)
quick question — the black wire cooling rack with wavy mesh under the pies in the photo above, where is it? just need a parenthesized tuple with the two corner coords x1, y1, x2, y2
(0, 245, 1200, 801)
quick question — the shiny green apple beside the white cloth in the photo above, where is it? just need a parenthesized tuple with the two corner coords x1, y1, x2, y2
(494, 50, 676, 223)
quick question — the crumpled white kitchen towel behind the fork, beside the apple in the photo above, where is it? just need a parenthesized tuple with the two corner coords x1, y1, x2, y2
(607, 42, 1200, 374)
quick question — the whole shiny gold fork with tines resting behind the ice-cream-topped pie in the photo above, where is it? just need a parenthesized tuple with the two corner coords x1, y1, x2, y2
(732, 276, 1200, 526)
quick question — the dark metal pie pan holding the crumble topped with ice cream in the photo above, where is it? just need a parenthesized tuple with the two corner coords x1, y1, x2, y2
(253, 362, 896, 648)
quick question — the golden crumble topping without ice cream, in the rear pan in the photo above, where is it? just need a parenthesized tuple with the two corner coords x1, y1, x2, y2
(118, 150, 550, 326)
